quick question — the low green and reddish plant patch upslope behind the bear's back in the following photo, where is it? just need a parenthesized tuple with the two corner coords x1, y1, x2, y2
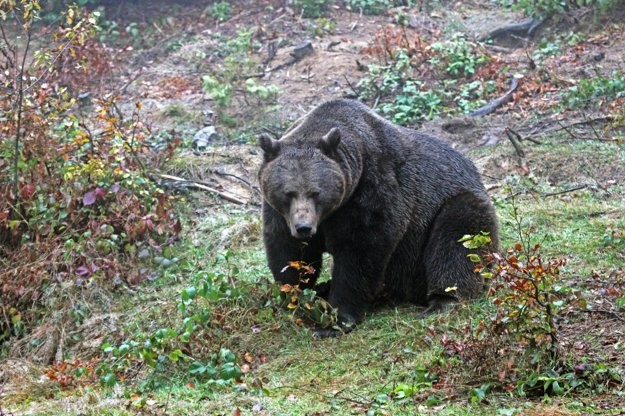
(357, 27, 504, 126)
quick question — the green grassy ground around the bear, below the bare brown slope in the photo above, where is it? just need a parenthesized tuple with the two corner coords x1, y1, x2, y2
(4, 134, 625, 415)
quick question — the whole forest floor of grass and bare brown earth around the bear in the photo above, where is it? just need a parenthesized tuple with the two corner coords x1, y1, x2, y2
(0, 0, 625, 415)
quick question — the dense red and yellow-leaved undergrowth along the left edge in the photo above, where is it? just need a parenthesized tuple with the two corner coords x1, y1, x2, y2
(0, 1, 180, 362)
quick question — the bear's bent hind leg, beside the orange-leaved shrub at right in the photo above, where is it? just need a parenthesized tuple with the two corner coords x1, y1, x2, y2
(422, 192, 498, 315)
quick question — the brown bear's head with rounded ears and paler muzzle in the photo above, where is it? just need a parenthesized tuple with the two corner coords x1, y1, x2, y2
(258, 128, 346, 239)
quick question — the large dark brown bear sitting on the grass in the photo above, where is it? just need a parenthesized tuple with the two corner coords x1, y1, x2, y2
(259, 99, 498, 337)
